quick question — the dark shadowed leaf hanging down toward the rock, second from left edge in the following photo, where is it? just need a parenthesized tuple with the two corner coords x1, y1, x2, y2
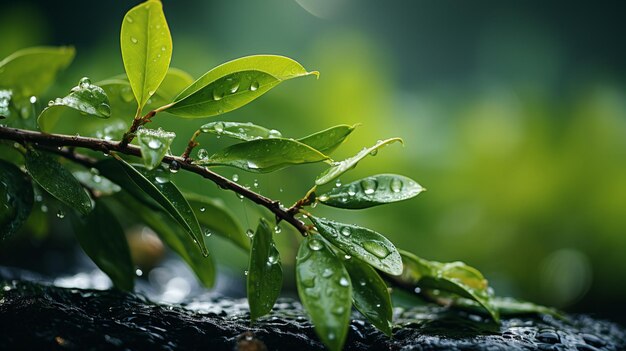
(72, 201, 135, 291)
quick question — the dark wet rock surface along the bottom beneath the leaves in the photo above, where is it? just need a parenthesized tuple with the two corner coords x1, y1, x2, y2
(0, 271, 626, 351)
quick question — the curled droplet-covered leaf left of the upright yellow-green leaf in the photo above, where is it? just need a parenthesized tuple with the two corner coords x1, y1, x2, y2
(37, 77, 111, 133)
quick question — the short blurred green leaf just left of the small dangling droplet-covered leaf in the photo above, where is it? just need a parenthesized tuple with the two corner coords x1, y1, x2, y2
(184, 193, 250, 251)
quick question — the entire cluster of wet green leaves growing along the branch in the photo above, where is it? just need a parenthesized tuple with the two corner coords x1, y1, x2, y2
(0, 0, 547, 350)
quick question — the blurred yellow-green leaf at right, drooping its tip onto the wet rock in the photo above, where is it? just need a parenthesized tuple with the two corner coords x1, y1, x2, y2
(400, 251, 500, 322)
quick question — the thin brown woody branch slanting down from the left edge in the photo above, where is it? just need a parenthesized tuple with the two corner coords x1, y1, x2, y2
(0, 127, 308, 235)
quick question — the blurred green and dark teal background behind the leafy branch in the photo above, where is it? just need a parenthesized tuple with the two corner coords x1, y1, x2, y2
(0, 0, 626, 322)
